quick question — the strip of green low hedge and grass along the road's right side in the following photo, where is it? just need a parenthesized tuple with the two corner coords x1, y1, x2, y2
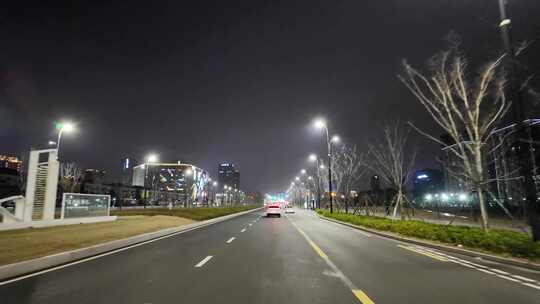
(317, 210, 540, 262)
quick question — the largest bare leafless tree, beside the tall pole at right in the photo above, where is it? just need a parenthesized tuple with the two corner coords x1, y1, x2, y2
(400, 48, 509, 231)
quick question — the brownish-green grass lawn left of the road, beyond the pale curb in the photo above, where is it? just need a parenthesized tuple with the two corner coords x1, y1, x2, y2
(0, 206, 256, 265)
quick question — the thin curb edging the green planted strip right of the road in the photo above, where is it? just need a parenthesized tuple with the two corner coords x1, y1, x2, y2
(317, 213, 540, 271)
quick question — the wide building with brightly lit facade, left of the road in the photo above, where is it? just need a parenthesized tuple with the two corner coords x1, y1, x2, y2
(133, 162, 210, 207)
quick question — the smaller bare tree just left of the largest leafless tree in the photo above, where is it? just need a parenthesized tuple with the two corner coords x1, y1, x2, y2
(367, 121, 416, 218)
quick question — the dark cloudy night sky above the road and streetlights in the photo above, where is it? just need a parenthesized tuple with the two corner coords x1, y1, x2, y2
(0, 0, 540, 191)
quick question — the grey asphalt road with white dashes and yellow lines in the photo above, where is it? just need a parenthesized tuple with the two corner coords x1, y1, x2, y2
(0, 210, 540, 304)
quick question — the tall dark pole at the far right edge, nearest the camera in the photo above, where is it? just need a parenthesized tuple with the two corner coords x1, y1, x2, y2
(498, 0, 540, 241)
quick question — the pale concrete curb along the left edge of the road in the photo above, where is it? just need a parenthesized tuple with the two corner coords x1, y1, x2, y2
(0, 207, 263, 283)
